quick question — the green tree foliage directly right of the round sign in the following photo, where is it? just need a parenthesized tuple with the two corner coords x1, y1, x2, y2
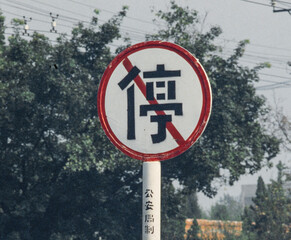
(151, 2, 279, 196)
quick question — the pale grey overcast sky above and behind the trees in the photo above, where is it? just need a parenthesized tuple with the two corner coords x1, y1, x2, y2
(0, 0, 291, 209)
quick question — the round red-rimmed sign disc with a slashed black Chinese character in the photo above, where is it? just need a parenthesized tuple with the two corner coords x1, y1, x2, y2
(98, 41, 211, 161)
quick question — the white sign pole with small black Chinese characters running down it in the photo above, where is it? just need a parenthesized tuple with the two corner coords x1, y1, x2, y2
(142, 161, 161, 240)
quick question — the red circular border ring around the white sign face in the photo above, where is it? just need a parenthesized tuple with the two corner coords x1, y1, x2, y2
(97, 41, 212, 161)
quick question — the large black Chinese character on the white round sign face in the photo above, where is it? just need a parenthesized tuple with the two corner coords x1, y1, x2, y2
(118, 64, 183, 143)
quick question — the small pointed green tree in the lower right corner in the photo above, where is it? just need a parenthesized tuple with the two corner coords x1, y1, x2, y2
(243, 163, 291, 240)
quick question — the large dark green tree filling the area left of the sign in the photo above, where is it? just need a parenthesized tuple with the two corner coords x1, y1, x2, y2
(0, 7, 145, 240)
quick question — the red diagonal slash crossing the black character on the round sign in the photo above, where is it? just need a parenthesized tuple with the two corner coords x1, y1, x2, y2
(123, 58, 185, 145)
